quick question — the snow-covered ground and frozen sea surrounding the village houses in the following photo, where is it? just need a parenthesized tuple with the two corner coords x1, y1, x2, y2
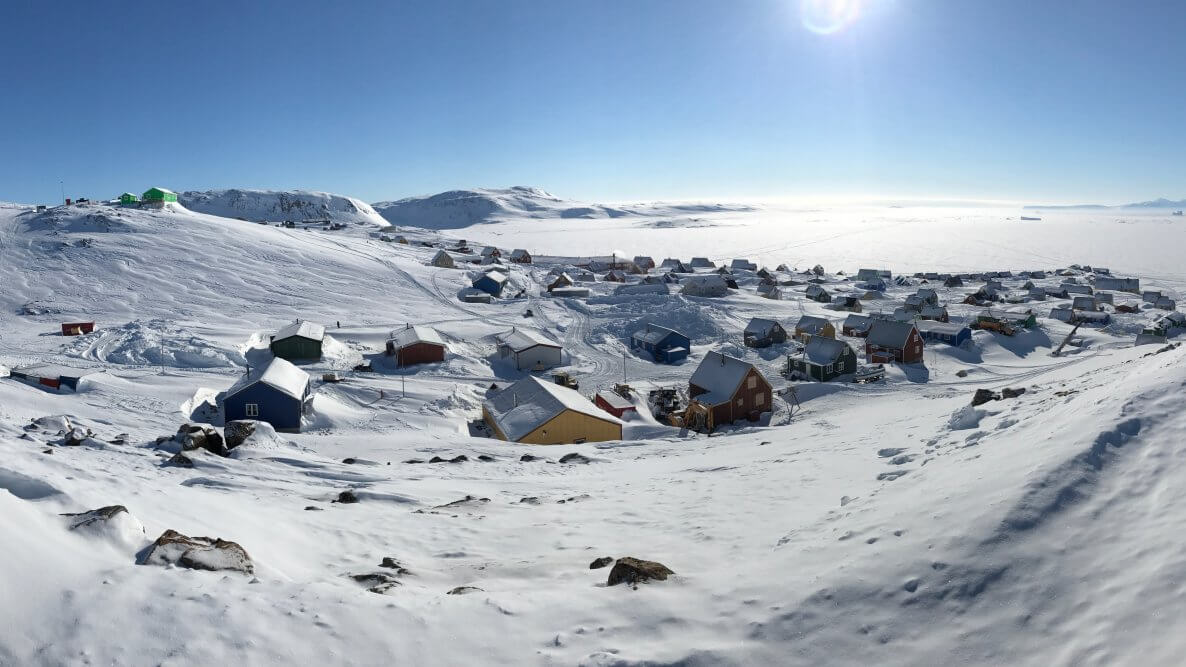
(0, 190, 1186, 665)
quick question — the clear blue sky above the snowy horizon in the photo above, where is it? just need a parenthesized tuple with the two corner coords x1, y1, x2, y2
(0, 0, 1186, 203)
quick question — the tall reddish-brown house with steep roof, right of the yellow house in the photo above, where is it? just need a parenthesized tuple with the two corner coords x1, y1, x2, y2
(686, 351, 773, 431)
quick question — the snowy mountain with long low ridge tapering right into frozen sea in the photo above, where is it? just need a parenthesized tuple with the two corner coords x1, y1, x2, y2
(371, 185, 752, 229)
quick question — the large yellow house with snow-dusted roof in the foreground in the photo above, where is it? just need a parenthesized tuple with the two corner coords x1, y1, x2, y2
(482, 377, 621, 445)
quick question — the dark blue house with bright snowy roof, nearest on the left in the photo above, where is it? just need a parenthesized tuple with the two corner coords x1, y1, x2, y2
(222, 357, 313, 432)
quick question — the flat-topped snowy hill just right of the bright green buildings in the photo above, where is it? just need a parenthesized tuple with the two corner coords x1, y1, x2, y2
(177, 189, 385, 225)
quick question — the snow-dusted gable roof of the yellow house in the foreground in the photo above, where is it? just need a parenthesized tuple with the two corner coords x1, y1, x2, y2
(483, 376, 621, 442)
